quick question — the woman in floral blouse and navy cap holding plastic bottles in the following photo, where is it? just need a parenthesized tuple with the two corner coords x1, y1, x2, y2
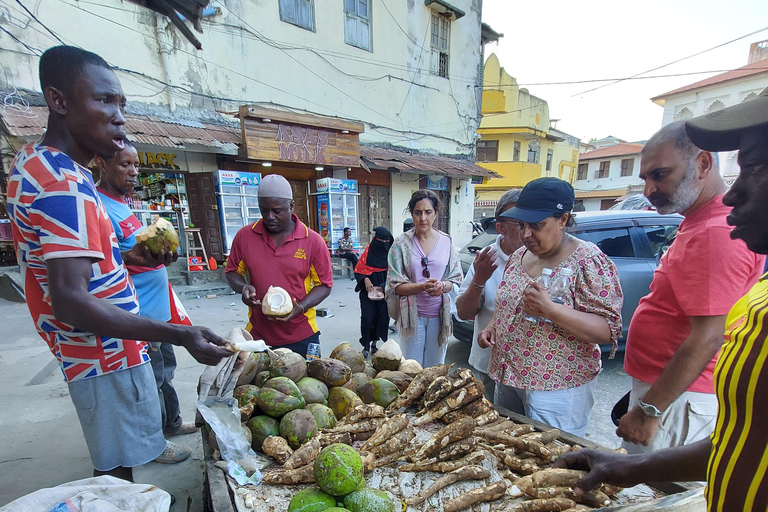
(477, 178, 623, 436)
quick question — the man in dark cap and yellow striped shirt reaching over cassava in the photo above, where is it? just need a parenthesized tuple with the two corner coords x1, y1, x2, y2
(557, 89, 768, 511)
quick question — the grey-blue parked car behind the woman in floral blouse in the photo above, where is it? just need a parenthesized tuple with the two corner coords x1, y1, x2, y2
(453, 210, 683, 351)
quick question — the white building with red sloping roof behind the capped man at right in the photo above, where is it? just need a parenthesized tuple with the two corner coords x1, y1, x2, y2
(651, 40, 768, 184)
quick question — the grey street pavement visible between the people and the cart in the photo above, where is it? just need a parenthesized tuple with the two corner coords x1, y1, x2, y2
(0, 278, 630, 512)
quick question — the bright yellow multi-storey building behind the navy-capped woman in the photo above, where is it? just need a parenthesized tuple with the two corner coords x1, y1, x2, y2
(475, 54, 580, 220)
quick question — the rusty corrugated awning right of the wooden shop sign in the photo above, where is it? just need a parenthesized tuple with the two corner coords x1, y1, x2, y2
(360, 146, 501, 178)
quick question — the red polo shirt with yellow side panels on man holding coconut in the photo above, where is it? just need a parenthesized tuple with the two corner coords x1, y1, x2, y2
(225, 214, 333, 346)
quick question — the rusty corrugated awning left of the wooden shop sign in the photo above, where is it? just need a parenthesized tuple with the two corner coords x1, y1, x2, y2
(0, 107, 242, 155)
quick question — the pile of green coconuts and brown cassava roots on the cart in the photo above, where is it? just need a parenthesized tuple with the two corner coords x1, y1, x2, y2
(222, 341, 632, 512)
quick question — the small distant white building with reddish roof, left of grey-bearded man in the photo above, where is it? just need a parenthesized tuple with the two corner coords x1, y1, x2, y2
(573, 142, 644, 211)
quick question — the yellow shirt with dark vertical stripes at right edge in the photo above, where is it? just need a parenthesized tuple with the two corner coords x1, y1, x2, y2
(706, 274, 768, 512)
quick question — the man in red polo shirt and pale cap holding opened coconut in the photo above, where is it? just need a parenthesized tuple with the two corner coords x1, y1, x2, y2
(225, 174, 333, 357)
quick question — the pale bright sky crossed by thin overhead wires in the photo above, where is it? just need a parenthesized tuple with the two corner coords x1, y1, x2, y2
(483, 0, 768, 141)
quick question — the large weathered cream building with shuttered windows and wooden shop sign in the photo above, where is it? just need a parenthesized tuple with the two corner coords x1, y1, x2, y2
(0, 0, 501, 259)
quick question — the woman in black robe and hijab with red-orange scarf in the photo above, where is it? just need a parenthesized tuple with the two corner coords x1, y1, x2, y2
(355, 226, 393, 357)
